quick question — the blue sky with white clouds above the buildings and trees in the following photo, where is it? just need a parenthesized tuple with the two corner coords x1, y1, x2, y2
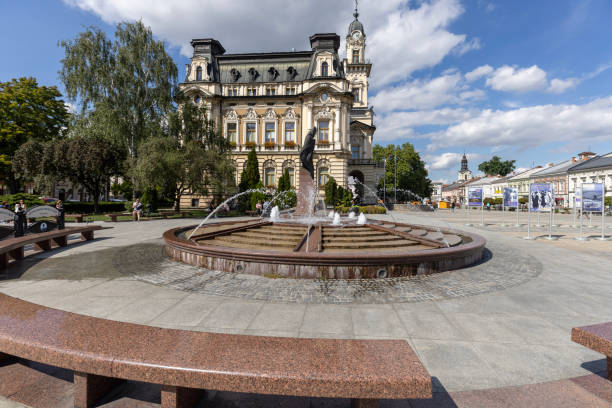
(0, 0, 612, 181)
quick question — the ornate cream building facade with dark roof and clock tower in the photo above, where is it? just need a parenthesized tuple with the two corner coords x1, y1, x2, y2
(179, 10, 383, 207)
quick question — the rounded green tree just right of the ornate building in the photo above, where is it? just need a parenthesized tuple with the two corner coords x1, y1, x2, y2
(373, 143, 433, 199)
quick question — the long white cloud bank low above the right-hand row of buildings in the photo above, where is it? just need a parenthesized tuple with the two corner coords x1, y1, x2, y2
(428, 96, 612, 151)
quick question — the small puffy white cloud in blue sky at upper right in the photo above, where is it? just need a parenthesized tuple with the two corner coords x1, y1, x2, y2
(486, 65, 547, 92)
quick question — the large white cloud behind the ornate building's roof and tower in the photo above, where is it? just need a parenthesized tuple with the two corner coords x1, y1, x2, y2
(64, 0, 479, 87)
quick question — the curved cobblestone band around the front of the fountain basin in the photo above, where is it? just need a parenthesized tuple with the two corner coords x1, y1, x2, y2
(112, 242, 542, 304)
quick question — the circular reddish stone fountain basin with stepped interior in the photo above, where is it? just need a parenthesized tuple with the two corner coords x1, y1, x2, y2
(164, 219, 486, 279)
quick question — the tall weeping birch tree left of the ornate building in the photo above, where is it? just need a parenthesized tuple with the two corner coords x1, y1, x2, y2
(59, 21, 178, 197)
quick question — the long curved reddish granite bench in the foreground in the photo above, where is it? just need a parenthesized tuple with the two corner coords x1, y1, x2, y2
(0, 294, 432, 408)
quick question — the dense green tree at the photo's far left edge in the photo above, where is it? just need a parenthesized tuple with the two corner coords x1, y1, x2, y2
(0, 78, 69, 193)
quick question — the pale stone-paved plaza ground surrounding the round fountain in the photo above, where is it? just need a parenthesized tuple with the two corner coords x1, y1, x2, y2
(0, 210, 612, 407)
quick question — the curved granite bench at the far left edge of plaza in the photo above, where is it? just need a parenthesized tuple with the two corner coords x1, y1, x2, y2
(0, 225, 102, 270)
